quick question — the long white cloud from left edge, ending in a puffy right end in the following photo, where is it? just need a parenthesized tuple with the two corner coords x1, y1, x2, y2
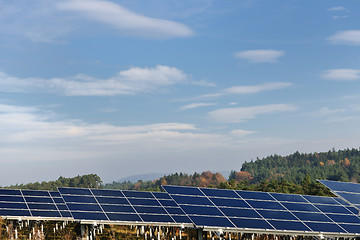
(0, 65, 188, 96)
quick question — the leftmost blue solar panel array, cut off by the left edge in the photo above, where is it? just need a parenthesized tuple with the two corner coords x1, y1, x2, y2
(0, 189, 72, 219)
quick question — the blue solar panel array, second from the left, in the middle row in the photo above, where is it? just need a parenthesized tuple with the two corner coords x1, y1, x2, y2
(59, 188, 192, 225)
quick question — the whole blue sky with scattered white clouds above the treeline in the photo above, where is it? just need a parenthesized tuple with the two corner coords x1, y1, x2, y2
(0, 0, 360, 186)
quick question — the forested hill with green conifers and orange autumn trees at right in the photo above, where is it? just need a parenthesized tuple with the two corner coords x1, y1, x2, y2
(241, 148, 360, 184)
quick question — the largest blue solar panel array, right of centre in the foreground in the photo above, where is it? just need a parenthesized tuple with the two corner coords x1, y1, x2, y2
(163, 186, 360, 234)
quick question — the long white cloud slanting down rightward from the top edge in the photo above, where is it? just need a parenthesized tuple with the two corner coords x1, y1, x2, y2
(57, 0, 194, 38)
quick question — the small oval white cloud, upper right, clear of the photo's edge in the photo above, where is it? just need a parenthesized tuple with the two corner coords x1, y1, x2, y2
(235, 49, 285, 63)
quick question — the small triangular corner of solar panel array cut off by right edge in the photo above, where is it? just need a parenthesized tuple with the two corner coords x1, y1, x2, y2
(319, 180, 360, 210)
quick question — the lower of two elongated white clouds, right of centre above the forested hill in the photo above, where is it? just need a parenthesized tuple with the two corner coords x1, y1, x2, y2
(208, 104, 296, 123)
